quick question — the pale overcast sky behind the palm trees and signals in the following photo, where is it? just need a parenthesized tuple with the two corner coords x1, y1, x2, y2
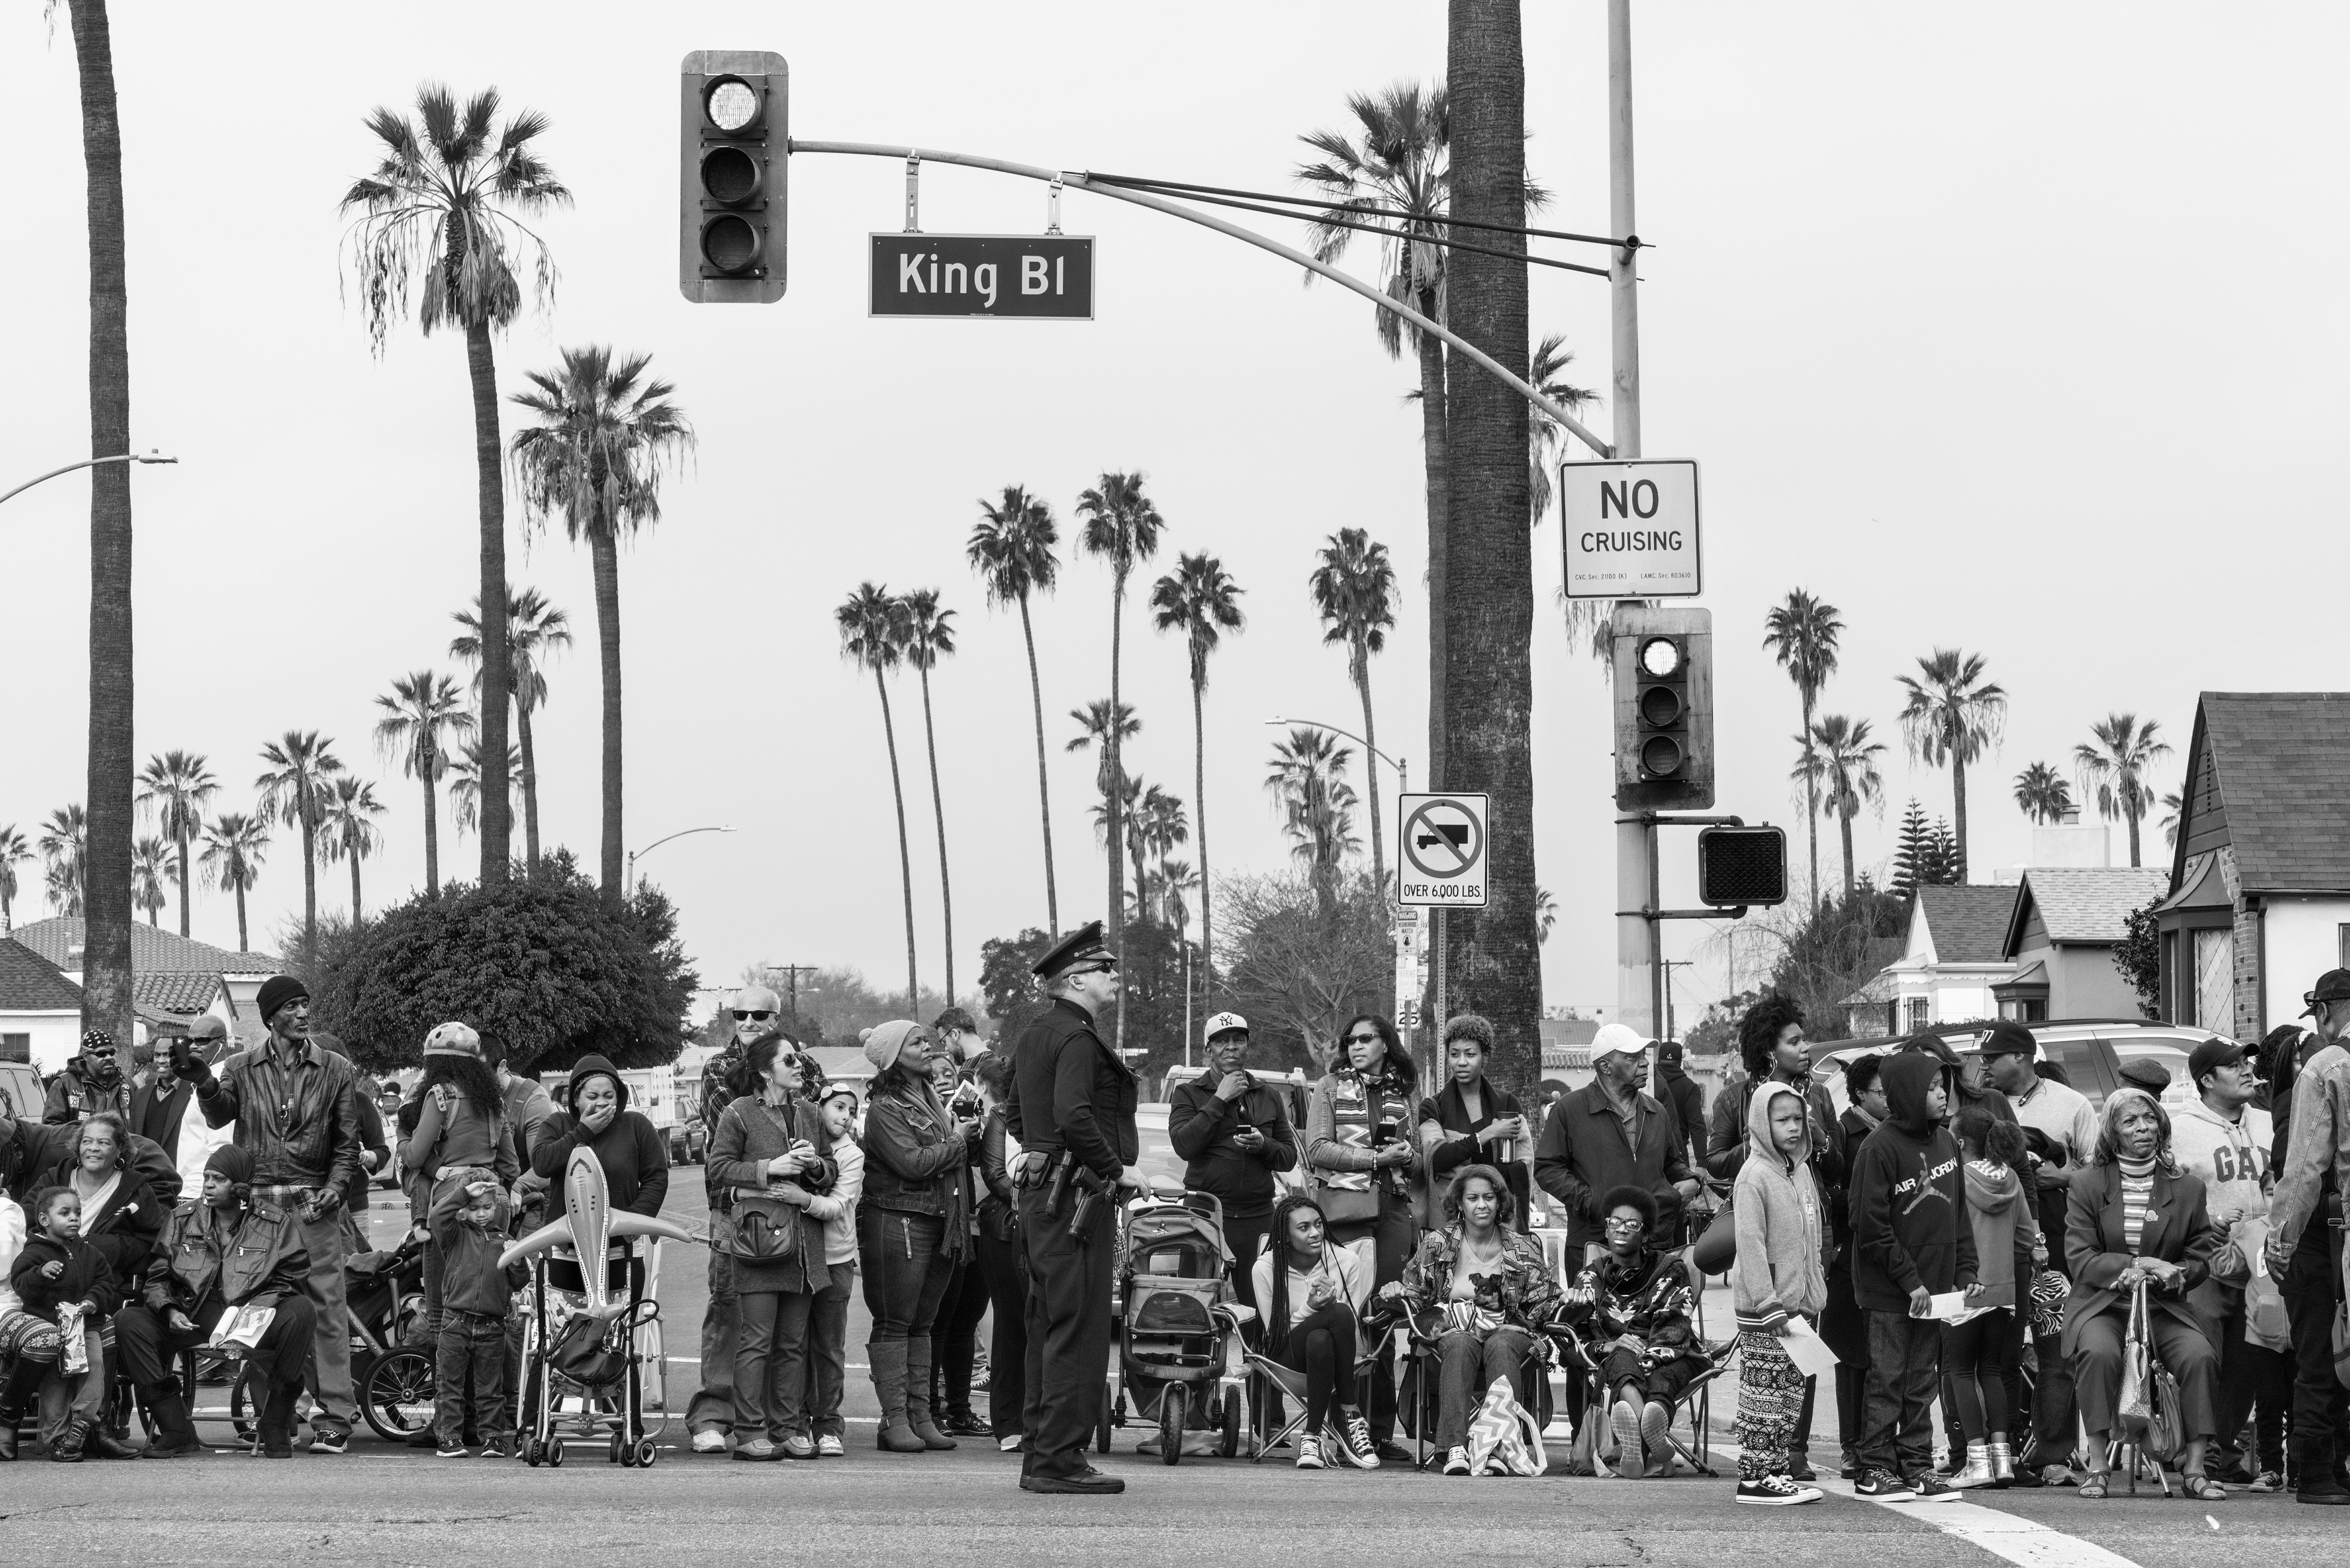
(0, 0, 2350, 1018)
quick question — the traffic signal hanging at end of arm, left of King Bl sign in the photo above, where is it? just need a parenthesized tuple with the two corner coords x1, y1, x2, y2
(677, 50, 792, 305)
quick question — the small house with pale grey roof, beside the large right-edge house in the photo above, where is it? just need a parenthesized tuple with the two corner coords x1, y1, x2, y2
(1991, 865, 2171, 1022)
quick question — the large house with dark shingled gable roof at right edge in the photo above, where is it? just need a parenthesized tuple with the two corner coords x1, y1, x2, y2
(2155, 691, 2350, 1041)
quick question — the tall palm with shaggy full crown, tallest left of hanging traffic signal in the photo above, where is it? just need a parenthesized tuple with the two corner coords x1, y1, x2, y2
(343, 83, 571, 886)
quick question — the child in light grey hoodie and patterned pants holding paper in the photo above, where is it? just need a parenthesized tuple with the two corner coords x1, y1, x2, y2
(1730, 1084, 1828, 1507)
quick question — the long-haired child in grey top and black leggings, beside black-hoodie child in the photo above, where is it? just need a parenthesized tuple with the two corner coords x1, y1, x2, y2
(1941, 1110, 2047, 1490)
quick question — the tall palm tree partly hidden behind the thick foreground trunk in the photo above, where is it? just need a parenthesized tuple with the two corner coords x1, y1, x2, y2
(1297, 83, 1448, 790)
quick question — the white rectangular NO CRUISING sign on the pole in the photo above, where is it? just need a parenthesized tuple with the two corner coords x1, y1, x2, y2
(1558, 460, 1704, 599)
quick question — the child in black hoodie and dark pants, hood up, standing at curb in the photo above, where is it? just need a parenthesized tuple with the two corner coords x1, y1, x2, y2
(1850, 1048, 1979, 1502)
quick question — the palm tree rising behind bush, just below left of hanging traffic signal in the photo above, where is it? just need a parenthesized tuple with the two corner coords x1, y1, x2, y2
(510, 348, 694, 903)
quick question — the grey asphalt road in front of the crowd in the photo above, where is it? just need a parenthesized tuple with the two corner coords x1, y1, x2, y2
(0, 1171, 2350, 1568)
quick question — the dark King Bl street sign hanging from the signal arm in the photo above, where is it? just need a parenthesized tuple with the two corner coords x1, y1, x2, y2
(865, 235, 1093, 322)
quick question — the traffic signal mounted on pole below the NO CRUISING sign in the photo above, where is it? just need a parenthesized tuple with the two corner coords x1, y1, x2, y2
(1610, 604, 1713, 811)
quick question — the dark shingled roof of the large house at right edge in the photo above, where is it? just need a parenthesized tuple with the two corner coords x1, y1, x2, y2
(2171, 691, 2350, 893)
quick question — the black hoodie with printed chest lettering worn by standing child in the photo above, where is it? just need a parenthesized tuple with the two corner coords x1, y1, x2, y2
(1850, 1051, 1974, 1312)
